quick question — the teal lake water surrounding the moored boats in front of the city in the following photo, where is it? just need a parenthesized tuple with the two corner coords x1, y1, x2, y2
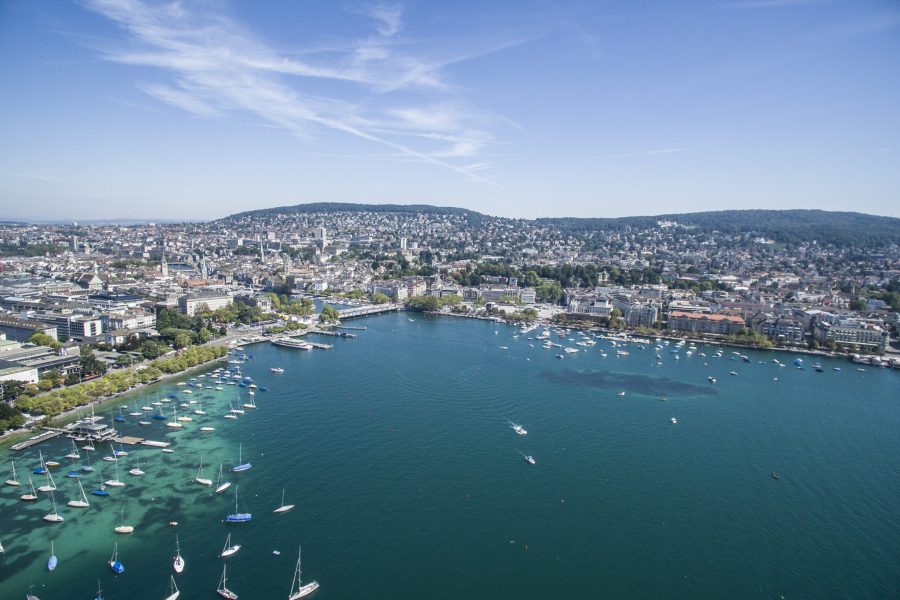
(0, 314, 900, 600)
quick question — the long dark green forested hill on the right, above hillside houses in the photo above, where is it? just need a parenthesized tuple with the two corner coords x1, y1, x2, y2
(536, 210, 900, 247)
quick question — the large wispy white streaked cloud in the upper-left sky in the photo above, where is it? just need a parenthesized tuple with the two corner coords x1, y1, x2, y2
(85, 0, 510, 181)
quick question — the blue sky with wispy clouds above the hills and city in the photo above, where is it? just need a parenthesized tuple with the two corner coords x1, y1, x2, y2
(0, 0, 900, 219)
